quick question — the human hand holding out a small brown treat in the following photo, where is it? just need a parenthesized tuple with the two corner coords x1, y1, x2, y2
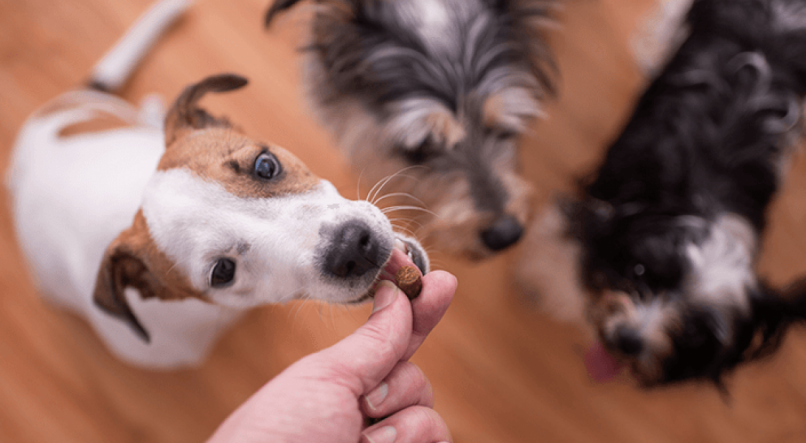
(208, 271, 456, 443)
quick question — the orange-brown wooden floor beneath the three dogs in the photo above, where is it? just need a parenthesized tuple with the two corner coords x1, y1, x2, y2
(0, 0, 806, 443)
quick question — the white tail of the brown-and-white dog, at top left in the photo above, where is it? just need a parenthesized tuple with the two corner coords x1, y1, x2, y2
(86, 0, 192, 92)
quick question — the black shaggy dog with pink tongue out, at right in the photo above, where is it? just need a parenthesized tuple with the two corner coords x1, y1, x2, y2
(519, 0, 806, 386)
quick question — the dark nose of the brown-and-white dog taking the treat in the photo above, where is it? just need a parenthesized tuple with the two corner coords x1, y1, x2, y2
(324, 220, 381, 278)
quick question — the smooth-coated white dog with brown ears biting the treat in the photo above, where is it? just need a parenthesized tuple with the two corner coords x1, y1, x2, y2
(9, 0, 428, 368)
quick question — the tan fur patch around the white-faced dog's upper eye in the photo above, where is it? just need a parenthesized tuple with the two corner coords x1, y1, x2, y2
(157, 127, 320, 198)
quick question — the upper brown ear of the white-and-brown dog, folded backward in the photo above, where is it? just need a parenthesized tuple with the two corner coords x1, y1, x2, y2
(165, 74, 247, 146)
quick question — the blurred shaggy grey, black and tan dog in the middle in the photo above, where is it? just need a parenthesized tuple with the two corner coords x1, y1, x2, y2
(266, 0, 555, 258)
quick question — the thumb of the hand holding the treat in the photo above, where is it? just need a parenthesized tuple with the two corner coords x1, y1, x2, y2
(317, 281, 412, 396)
